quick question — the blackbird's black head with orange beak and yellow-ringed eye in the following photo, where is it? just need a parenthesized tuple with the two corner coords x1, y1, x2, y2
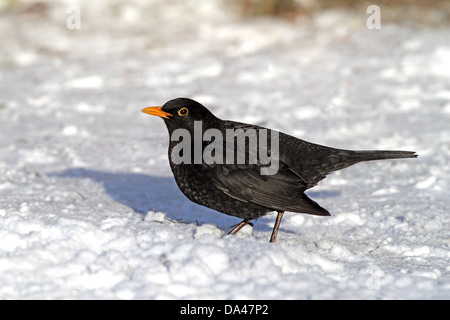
(142, 98, 217, 132)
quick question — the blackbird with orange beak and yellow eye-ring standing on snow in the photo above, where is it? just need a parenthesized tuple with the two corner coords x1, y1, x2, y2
(142, 98, 417, 242)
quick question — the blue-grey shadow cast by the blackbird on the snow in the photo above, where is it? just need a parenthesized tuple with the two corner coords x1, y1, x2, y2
(51, 168, 339, 232)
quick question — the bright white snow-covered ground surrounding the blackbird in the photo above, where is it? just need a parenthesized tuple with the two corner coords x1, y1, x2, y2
(0, 0, 450, 299)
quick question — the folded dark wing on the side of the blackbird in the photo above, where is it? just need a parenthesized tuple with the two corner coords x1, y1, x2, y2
(212, 163, 330, 216)
